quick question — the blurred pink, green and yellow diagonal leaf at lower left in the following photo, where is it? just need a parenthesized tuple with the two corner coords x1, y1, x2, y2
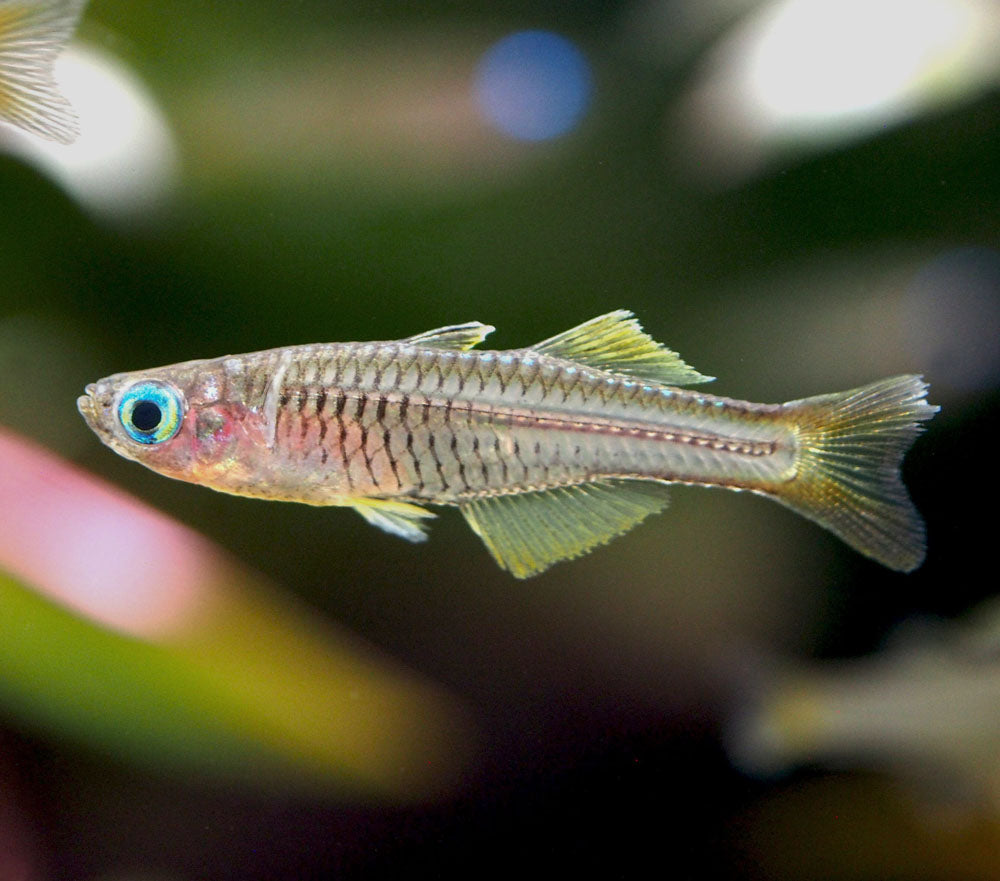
(0, 429, 474, 796)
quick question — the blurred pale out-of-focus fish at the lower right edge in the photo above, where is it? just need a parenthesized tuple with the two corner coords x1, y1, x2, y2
(724, 598, 1000, 817)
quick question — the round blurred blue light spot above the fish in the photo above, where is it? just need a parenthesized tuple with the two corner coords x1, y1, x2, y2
(476, 31, 591, 141)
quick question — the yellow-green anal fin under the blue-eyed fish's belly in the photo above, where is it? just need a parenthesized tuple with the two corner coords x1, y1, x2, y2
(461, 480, 667, 578)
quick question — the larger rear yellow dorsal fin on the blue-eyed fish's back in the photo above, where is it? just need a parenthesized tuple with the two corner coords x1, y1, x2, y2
(531, 309, 714, 385)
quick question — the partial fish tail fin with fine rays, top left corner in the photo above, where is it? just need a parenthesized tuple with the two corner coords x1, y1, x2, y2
(0, 0, 87, 144)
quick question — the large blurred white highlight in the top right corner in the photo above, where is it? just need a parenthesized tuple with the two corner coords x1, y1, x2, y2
(666, 0, 1000, 183)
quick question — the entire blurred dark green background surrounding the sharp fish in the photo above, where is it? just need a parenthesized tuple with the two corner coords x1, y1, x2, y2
(0, 0, 1000, 881)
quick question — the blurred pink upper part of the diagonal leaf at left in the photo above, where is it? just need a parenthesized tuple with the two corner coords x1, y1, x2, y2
(0, 429, 220, 638)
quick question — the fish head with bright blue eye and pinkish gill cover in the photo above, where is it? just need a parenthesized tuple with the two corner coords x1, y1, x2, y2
(77, 361, 261, 492)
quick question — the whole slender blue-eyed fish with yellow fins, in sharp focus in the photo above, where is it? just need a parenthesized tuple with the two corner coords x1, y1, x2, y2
(78, 309, 938, 578)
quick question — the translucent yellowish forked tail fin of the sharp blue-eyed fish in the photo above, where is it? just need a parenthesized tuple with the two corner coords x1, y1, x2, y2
(767, 376, 939, 572)
